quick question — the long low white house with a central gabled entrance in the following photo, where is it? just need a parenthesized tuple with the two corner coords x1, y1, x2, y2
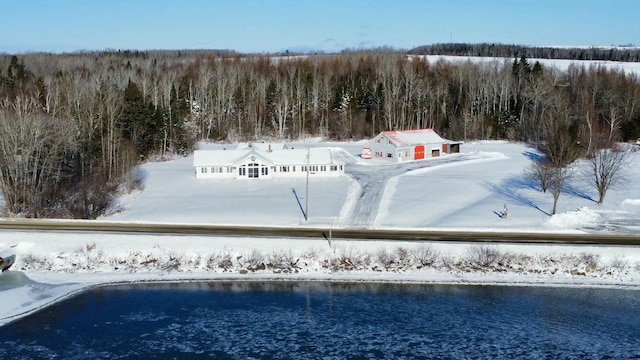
(193, 144, 344, 179)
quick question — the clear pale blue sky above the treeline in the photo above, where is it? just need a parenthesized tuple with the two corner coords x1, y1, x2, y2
(0, 0, 640, 53)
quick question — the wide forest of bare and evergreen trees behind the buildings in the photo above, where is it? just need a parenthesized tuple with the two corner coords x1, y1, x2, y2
(0, 51, 640, 218)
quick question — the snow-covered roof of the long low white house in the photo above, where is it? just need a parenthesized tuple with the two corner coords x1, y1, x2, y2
(193, 147, 340, 166)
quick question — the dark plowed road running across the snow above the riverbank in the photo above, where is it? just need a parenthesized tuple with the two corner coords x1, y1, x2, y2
(0, 219, 640, 246)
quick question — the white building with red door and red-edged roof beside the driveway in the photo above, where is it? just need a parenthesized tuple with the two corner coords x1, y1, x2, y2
(361, 129, 460, 162)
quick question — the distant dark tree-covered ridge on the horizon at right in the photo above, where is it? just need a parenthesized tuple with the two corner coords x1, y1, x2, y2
(408, 43, 640, 62)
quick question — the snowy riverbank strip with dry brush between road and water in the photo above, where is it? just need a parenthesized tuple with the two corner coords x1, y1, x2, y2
(0, 232, 640, 323)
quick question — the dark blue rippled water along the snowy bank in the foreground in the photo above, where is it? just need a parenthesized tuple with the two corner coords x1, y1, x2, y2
(0, 282, 640, 359)
